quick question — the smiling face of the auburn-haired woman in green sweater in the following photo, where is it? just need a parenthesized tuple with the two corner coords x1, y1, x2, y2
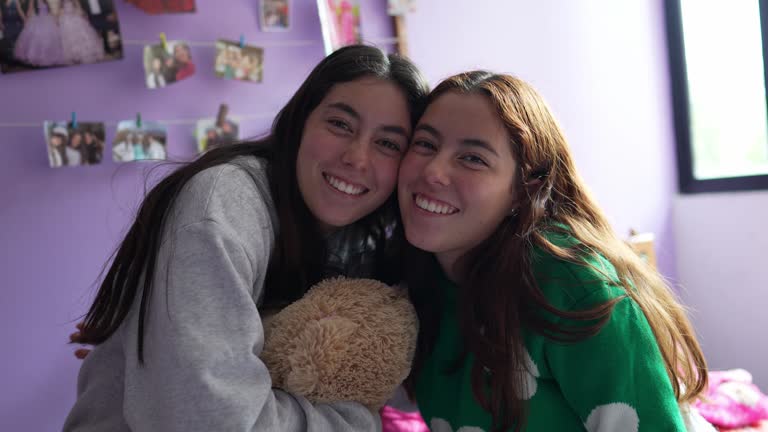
(398, 92, 517, 272)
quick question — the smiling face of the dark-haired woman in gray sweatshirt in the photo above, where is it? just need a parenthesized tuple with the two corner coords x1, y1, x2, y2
(296, 78, 411, 230)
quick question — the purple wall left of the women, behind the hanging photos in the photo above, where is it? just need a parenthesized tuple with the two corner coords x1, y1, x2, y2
(0, 0, 393, 431)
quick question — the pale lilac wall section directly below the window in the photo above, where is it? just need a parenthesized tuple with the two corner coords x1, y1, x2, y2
(675, 191, 768, 386)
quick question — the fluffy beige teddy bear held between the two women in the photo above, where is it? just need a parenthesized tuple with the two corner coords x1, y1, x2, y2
(261, 277, 418, 411)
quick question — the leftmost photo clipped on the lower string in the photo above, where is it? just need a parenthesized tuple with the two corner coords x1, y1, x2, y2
(44, 122, 104, 168)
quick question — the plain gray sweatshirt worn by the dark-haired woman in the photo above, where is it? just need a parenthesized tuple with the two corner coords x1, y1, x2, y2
(64, 157, 381, 432)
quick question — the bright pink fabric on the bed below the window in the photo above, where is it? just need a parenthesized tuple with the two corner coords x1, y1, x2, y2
(693, 369, 768, 431)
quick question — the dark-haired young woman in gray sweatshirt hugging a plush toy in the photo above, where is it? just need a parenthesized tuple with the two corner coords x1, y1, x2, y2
(64, 46, 428, 432)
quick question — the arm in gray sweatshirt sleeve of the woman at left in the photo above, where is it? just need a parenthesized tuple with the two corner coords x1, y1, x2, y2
(118, 166, 381, 432)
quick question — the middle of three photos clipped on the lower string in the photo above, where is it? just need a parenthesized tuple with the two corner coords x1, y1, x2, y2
(112, 120, 168, 162)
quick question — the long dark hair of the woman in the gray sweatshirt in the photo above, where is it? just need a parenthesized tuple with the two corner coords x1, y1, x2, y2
(79, 45, 429, 364)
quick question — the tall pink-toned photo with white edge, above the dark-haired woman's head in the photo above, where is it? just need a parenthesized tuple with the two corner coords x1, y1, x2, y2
(317, 0, 362, 55)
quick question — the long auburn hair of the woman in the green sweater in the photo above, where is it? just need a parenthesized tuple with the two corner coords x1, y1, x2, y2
(406, 71, 707, 431)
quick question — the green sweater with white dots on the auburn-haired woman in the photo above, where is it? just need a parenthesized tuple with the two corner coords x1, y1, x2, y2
(416, 238, 686, 432)
